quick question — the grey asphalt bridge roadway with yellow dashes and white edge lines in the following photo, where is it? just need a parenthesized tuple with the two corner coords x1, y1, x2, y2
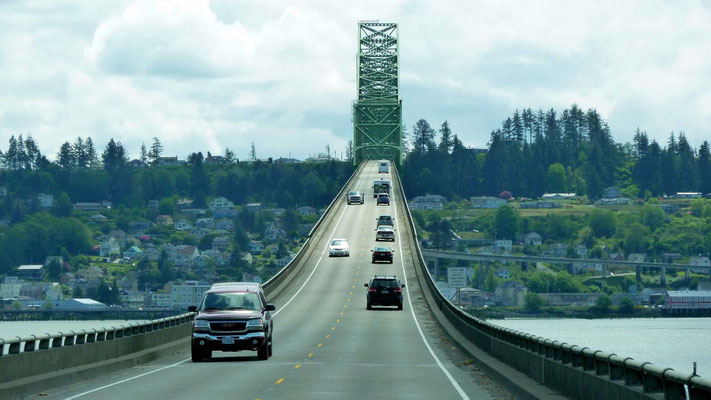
(43, 162, 510, 400)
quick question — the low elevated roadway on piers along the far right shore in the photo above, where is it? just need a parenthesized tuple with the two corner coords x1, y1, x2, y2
(422, 249, 711, 285)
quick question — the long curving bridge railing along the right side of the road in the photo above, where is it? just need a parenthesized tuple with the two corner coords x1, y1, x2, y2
(395, 169, 711, 400)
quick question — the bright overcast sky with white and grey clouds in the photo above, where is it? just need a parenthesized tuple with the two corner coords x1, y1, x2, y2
(0, 0, 711, 159)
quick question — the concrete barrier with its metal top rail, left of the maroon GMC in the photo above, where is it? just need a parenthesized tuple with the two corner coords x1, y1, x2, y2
(0, 313, 194, 399)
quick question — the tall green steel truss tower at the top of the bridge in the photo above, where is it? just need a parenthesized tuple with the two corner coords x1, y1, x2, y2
(353, 22, 402, 165)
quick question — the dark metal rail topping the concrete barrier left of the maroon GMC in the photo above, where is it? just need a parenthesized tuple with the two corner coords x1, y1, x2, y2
(0, 313, 195, 357)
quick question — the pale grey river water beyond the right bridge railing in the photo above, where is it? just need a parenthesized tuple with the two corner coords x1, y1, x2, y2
(489, 318, 711, 378)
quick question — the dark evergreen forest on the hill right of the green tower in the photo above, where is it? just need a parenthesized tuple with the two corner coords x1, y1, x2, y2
(403, 105, 711, 198)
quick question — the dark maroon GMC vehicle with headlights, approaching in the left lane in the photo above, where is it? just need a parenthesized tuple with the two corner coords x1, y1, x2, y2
(188, 282, 276, 362)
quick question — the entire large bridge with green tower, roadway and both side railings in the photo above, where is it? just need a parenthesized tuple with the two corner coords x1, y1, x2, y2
(0, 22, 711, 400)
